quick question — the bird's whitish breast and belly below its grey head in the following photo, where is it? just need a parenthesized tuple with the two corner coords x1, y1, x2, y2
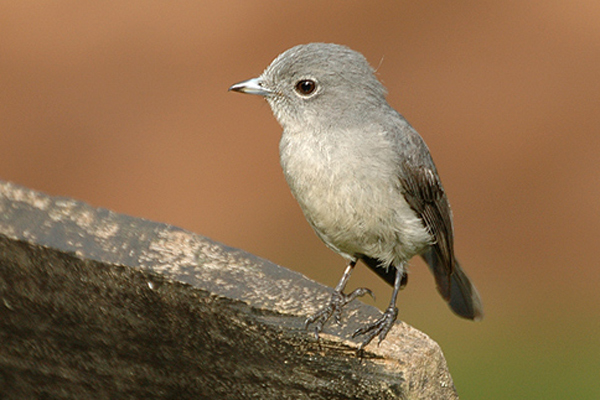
(280, 127, 430, 263)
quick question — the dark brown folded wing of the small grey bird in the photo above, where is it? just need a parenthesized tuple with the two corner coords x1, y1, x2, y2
(399, 162, 455, 300)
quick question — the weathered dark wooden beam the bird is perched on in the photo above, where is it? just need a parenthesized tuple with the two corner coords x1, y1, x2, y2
(0, 182, 458, 399)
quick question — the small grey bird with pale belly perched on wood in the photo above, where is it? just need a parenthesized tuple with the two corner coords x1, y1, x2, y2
(229, 43, 483, 349)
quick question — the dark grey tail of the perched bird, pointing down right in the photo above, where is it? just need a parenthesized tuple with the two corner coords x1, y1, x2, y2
(422, 249, 483, 321)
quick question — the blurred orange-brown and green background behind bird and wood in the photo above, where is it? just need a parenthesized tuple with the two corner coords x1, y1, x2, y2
(0, 0, 600, 399)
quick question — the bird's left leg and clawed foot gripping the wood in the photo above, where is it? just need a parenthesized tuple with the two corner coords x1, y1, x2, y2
(304, 260, 373, 339)
